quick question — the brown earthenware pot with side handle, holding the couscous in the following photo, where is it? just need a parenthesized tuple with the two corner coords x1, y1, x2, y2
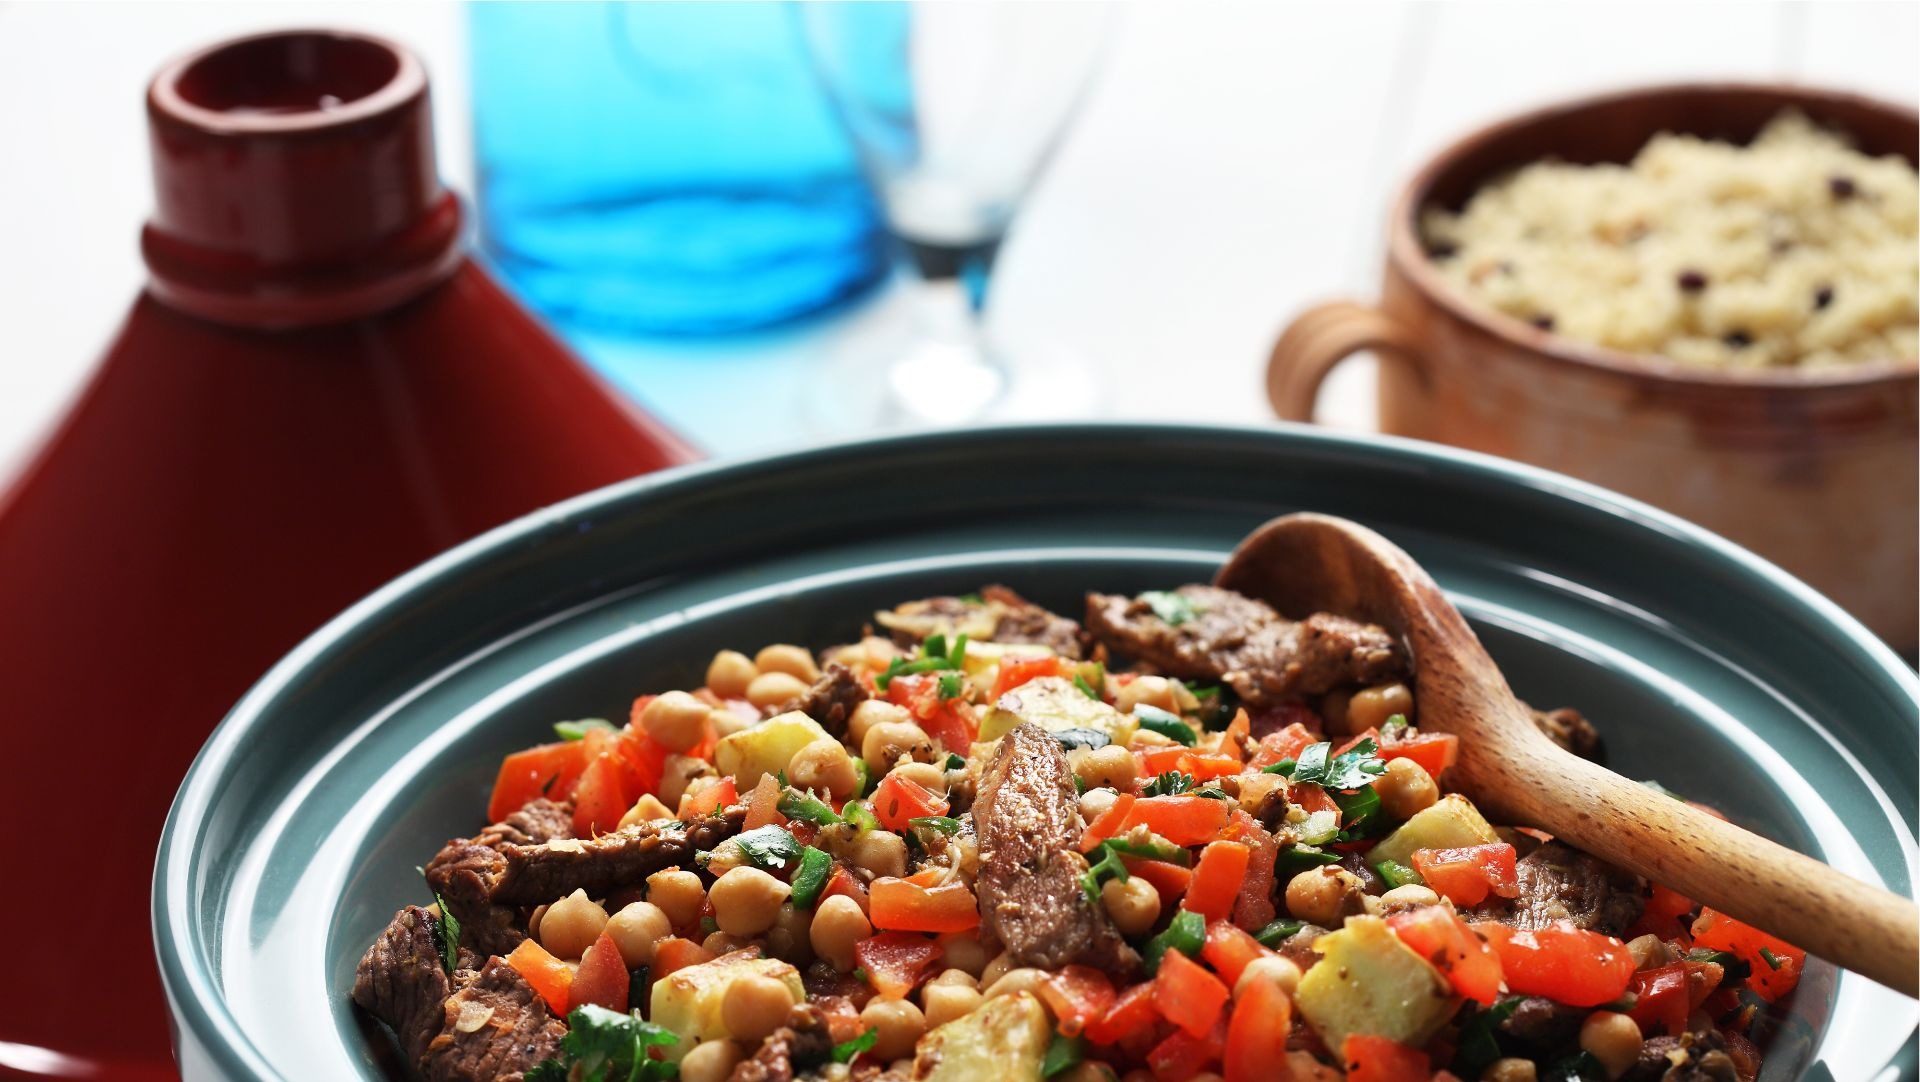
(1267, 84, 1920, 654)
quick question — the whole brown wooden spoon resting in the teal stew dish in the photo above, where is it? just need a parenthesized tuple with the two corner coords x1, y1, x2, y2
(1213, 514, 1920, 996)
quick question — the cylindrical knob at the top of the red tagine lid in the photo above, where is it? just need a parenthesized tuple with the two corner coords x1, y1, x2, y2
(140, 31, 461, 328)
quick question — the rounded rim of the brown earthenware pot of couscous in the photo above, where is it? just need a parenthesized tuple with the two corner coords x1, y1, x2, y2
(1388, 81, 1920, 391)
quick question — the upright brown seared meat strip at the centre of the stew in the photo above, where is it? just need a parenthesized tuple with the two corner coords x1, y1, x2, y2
(973, 723, 1140, 973)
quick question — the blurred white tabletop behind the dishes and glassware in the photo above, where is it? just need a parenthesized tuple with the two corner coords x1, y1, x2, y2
(0, 0, 1920, 464)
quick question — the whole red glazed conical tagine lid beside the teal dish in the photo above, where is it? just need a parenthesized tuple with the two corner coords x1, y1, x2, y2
(0, 33, 693, 1078)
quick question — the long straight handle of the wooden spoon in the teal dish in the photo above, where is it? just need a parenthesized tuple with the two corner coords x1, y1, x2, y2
(1476, 739, 1920, 996)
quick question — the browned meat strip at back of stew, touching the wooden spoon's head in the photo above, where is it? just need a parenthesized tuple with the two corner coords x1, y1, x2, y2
(1087, 585, 1407, 706)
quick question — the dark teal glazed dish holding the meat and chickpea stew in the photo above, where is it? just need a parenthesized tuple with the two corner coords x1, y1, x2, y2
(154, 426, 1920, 1082)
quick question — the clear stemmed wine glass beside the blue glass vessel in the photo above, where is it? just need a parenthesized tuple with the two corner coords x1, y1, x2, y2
(797, 2, 1116, 430)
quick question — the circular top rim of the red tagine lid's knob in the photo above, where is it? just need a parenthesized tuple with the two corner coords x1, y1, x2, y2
(146, 27, 426, 136)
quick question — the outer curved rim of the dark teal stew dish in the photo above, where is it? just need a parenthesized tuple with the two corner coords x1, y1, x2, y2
(150, 420, 1920, 1078)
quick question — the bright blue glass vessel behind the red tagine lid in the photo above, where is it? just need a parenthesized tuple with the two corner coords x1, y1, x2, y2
(468, 2, 887, 334)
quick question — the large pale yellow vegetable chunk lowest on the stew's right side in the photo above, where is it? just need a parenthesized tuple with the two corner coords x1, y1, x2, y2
(1294, 917, 1459, 1047)
